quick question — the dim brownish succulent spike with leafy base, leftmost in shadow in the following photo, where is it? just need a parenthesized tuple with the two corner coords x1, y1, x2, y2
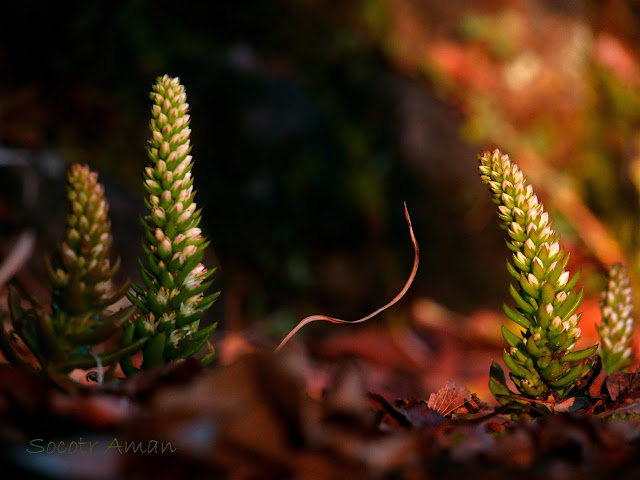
(0, 164, 146, 380)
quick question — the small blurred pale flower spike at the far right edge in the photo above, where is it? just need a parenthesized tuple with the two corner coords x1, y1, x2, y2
(596, 264, 633, 374)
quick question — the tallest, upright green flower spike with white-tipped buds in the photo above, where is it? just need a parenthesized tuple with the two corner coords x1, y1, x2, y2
(121, 75, 219, 374)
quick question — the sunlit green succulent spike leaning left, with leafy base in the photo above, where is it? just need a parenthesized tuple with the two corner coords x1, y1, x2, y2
(478, 150, 598, 403)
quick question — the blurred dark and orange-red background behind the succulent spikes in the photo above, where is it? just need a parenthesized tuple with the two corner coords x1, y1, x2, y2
(0, 0, 640, 394)
